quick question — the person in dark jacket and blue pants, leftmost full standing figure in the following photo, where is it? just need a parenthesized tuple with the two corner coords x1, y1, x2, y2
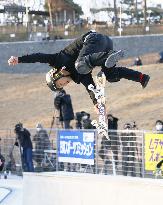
(15, 123, 34, 172)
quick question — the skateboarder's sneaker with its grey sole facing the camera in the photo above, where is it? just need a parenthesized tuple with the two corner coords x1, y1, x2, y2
(105, 50, 124, 68)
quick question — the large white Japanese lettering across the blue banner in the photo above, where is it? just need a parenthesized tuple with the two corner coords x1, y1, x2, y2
(60, 140, 93, 156)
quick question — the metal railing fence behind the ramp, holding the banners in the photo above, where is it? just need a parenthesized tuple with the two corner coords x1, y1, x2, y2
(0, 129, 163, 178)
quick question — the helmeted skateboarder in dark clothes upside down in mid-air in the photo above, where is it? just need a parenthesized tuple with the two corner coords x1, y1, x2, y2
(8, 31, 150, 108)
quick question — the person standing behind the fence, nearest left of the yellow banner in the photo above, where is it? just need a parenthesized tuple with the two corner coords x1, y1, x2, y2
(121, 123, 137, 177)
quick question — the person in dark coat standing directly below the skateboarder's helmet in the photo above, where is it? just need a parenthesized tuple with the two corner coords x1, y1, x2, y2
(54, 90, 74, 129)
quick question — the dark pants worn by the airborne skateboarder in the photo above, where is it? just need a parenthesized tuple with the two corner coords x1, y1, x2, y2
(77, 33, 141, 82)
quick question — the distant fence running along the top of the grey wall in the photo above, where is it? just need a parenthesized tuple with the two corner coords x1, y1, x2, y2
(0, 23, 163, 42)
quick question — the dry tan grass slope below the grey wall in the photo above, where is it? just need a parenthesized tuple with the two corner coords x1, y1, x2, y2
(0, 54, 163, 129)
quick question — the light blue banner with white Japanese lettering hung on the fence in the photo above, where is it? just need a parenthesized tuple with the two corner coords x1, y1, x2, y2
(57, 130, 95, 165)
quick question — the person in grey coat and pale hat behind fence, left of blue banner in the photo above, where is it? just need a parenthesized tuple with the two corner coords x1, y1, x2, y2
(33, 123, 50, 168)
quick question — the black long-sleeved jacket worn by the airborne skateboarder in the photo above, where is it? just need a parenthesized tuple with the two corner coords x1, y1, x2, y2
(18, 32, 97, 104)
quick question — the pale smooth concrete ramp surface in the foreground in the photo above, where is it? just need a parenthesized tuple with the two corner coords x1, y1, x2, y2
(23, 172, 163, 205)
